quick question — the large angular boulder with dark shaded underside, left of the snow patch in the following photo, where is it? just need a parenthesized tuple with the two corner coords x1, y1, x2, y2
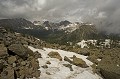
(8, 44, 34, 58)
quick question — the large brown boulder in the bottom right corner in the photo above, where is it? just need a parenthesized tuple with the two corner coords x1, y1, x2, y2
(98, 56, 120, 79)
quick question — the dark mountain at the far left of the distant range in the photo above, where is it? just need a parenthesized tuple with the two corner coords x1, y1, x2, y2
(0, 18, 34, 30)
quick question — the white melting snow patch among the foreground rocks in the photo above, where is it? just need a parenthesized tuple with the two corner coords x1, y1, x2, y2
(28, 46, 102, 79)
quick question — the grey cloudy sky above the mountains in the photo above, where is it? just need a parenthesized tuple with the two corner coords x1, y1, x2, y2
(0, 0, 120, 33)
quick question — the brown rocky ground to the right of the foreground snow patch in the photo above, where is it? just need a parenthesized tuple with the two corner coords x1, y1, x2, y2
(87, 48, 120, 79)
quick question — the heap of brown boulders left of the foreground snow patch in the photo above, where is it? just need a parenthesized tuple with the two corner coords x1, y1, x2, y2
(0, 28, 41, 79)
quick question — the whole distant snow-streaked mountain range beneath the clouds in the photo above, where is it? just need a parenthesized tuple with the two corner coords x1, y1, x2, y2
(0, 18, 120, 44)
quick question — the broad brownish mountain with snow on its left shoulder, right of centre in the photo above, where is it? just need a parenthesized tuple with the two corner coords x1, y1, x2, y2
(44, 23, 99, 44)
